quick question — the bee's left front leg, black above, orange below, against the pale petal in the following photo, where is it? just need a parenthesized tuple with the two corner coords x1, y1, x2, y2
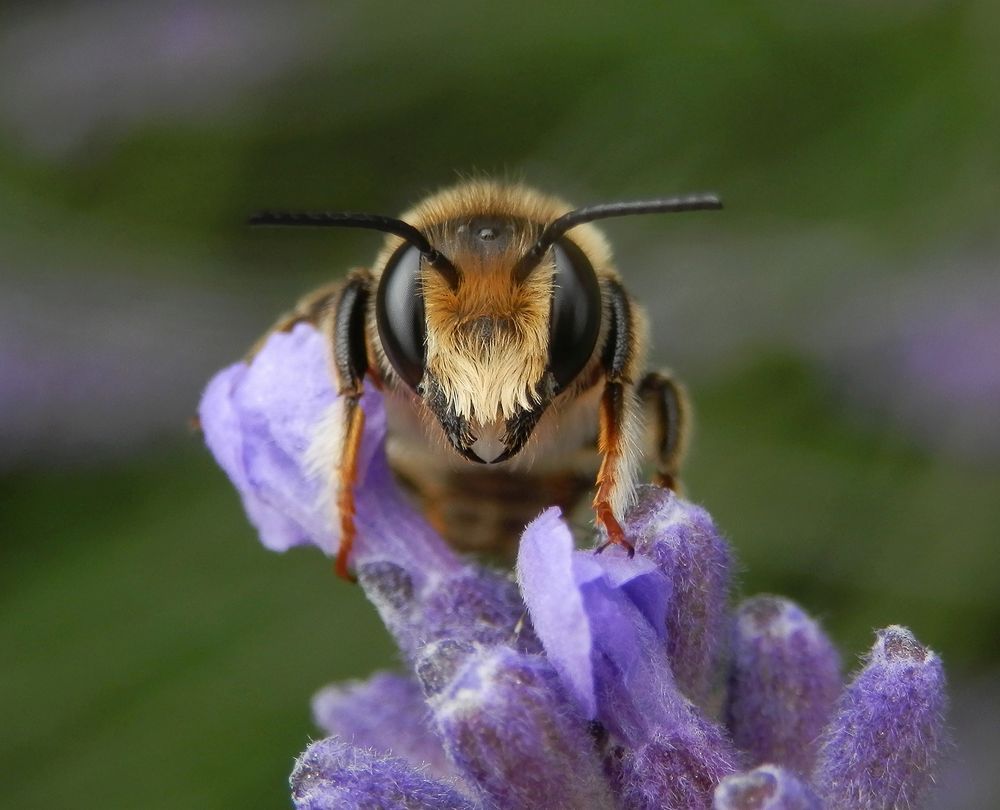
(328, 270, 371, 581)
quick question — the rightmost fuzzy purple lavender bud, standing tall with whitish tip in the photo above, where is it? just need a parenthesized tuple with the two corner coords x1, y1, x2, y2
(815, 626, 947, 808)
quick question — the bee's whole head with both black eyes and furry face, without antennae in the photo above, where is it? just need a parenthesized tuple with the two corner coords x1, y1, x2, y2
(375, 184, 611, 463)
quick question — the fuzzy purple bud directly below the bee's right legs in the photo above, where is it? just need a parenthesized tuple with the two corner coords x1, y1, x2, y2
(624, 486, 733, 702)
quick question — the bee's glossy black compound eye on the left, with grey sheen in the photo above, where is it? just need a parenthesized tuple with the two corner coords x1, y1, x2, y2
(375, 245, 427, 390)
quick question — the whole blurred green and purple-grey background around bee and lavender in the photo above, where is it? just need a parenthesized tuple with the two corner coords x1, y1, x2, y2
(0, 0, 1000, 808)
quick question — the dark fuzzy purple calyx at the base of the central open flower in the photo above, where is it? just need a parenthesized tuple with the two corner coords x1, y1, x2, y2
(605, 704, 737, 810)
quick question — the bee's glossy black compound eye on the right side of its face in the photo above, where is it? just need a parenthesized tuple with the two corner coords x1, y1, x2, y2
(549, 239, 601, 390)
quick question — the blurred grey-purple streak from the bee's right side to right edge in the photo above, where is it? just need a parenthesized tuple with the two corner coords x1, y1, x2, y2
(636, 234, 1000, 467)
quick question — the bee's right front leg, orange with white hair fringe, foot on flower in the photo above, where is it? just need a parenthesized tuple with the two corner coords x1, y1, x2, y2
(593, 281, 638, 557)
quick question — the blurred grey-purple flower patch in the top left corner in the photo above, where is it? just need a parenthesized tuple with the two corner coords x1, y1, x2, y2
(0, 0, 350, 157)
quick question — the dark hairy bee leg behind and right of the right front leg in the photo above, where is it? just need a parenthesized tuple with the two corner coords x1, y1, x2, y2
(638, 371, 691, 492)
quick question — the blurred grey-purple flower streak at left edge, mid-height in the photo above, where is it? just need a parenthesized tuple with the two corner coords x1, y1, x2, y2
(0, 266, 269, 471)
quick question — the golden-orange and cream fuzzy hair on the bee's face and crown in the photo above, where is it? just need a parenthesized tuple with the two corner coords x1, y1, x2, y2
(375, 181, 614, 434)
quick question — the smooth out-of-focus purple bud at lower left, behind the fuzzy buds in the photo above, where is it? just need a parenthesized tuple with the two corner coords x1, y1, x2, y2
(312, 672, 451, 777)
